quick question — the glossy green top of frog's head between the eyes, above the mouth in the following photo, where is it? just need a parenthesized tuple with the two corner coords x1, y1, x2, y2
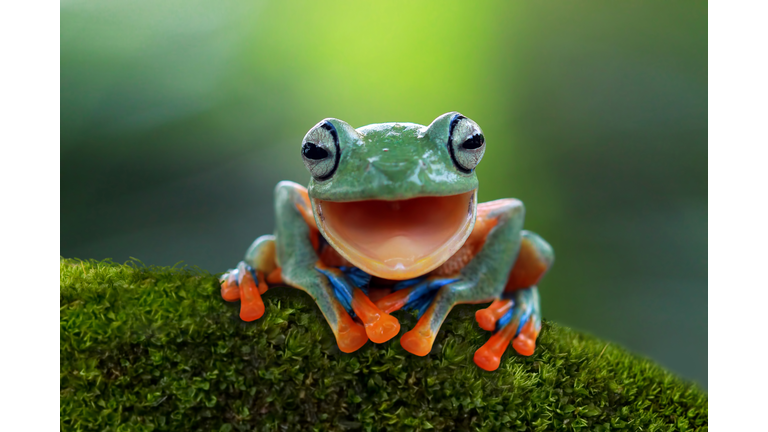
(308, 113, 478, 201)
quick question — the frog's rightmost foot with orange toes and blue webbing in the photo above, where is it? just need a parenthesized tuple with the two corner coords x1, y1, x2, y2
(474, 286, 541, 371)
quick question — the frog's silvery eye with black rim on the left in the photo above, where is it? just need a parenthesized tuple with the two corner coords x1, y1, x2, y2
(301, 120, 341, 181)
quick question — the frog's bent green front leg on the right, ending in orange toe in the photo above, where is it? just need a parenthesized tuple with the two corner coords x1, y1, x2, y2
(392, 199, 525, 356)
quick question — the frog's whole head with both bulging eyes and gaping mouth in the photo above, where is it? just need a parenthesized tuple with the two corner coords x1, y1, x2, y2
(301, 112, 485, 280)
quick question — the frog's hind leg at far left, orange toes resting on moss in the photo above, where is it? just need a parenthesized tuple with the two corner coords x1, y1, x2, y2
(221, 235, 279, 321)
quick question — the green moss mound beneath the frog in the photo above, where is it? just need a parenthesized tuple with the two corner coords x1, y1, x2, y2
(60, 260, 708, 431)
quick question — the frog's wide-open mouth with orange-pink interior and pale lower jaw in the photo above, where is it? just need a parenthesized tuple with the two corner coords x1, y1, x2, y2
(312, 189, 477, 280)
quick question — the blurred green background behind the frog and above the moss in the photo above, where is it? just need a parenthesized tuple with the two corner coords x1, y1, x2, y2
(61, 0, 707, 387)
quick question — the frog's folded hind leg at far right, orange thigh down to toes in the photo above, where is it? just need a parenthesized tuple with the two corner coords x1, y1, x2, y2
(475, 231, 555, 370)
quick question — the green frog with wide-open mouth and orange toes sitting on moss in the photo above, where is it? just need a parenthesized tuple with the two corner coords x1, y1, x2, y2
(220, 112, 554, 371)
